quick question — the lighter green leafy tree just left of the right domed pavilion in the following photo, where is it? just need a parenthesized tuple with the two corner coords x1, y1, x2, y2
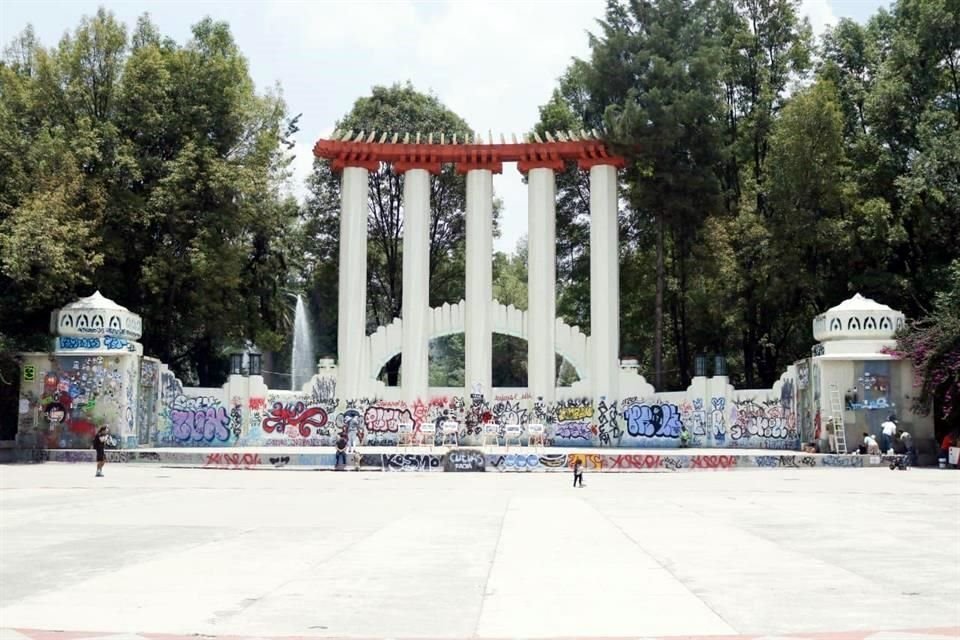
(712, 81, 858, 384)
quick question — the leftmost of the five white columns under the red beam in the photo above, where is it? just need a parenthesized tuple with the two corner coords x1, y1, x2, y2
(337, 167, 368, 400)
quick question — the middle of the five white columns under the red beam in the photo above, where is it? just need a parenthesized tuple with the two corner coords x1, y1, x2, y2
(464, 169, 493, 398)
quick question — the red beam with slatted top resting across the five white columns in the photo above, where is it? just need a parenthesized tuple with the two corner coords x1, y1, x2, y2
(313, 139, 624, 174)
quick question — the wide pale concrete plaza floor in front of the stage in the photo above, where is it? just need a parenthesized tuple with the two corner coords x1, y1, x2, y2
(0, 463, 960, 638)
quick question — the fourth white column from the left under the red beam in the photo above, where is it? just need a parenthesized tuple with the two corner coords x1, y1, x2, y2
(527, 169, 557, 402)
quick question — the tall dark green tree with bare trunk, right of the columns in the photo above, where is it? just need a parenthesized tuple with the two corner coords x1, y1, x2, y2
(587, 0, 720, 388)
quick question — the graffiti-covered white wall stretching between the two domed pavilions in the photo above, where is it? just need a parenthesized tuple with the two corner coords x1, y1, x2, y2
(133, 371, 800, 449)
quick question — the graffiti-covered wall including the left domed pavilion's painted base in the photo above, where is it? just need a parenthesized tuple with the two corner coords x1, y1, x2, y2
(18, 344, 804, 450)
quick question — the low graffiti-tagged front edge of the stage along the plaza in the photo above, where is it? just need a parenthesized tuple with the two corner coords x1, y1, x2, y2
(18, 449, 900, 473)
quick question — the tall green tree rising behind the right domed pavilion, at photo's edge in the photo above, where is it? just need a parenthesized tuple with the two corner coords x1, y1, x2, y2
(820, 0, 960, 316)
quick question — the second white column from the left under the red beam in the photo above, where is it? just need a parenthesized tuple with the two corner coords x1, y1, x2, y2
(400, 169, 430, 403)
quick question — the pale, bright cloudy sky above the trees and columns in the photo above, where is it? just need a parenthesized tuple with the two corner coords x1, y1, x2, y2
(0, 0, 888, 251)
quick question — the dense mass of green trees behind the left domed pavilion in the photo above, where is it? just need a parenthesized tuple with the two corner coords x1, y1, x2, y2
(0, 10, 297, 385)
